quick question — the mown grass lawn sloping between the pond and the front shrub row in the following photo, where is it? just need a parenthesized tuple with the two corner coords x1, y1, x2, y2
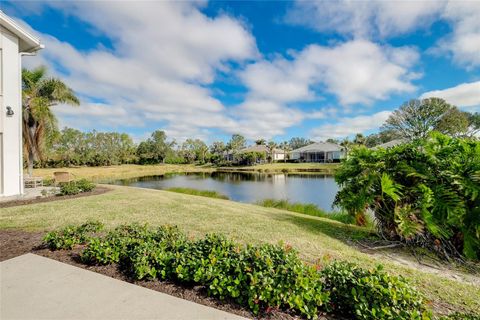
(0, 185, 480, 311)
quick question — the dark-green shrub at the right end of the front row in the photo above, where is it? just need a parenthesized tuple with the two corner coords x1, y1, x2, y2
(322, 262, 430, 319)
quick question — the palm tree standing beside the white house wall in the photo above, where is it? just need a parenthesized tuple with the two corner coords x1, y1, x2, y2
(22, 67, 80, 176)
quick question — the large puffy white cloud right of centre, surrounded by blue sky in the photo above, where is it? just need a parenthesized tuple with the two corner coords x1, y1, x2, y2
(233, 40, 418, 138)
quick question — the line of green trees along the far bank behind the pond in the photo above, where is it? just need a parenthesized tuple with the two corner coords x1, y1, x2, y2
(37, 128, 312, 167)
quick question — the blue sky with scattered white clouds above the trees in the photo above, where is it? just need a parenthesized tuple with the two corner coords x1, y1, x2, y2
(0, 0, 480, 142)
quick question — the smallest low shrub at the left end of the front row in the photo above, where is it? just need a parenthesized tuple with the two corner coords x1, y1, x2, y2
(43, 221, 103, 250)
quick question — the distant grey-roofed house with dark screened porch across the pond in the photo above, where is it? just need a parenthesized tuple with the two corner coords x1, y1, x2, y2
(290, 142, 345, 163)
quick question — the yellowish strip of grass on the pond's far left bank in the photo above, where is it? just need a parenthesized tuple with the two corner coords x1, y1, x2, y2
(33, 164, 214, 181)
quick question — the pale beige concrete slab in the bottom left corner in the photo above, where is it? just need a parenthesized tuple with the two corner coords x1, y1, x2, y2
(0, 253, 248, 320)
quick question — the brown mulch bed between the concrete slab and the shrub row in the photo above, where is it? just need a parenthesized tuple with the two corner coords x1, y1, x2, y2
(0, 230, 334, 320)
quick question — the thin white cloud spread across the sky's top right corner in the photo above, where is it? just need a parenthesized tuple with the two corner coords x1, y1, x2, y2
(285, 0, 480, 69)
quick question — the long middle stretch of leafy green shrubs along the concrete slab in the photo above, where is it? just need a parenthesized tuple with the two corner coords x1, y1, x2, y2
(81, 226, 328, 318)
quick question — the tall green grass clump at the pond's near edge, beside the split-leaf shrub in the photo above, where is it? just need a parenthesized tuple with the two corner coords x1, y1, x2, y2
(257, 199, 355, 224)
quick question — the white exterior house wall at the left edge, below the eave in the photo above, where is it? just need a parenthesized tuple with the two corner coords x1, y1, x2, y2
(0, 26, 23, 196)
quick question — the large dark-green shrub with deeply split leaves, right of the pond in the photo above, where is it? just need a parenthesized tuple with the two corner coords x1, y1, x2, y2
(335, 134, 480, 259)
